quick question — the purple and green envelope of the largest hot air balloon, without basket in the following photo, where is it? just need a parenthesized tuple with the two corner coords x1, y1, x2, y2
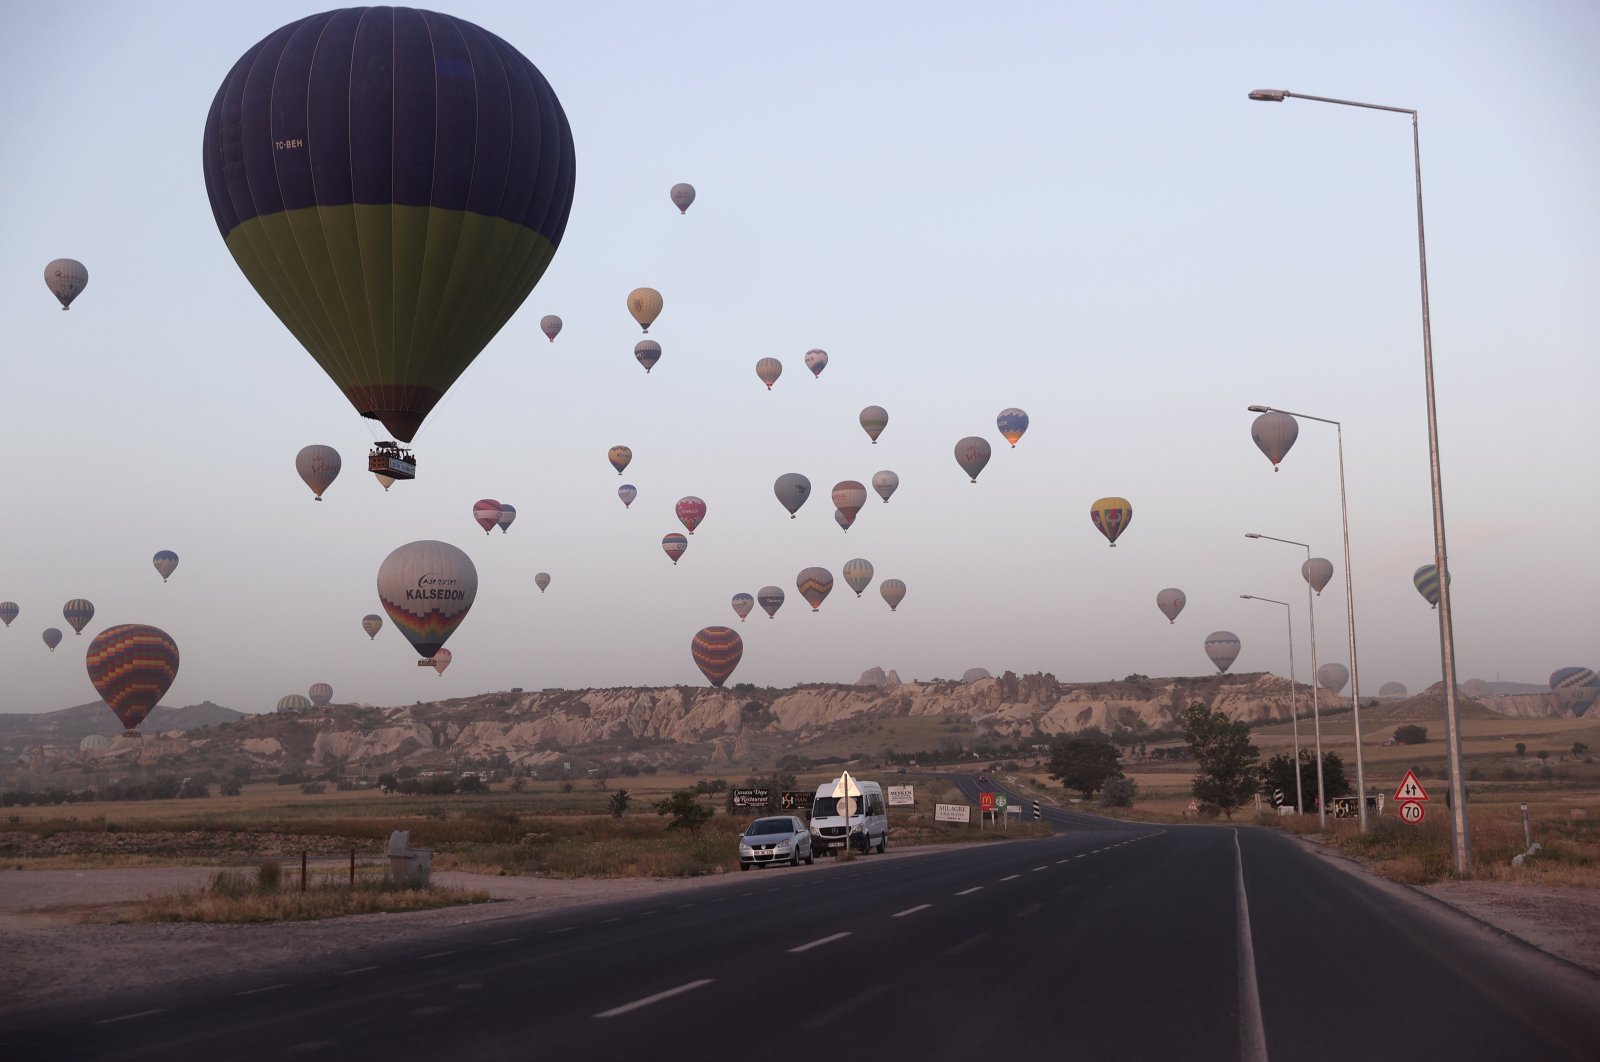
(203, 8, 574, 441)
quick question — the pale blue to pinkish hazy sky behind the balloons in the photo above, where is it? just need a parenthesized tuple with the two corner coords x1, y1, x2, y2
(0, 0, 1600, 712)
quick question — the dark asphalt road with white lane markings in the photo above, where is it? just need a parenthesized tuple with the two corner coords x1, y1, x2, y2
(0, 812, 1600, 1062)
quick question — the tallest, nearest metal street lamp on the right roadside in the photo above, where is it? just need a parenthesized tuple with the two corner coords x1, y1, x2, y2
(1250, 88, 1472, 875)
